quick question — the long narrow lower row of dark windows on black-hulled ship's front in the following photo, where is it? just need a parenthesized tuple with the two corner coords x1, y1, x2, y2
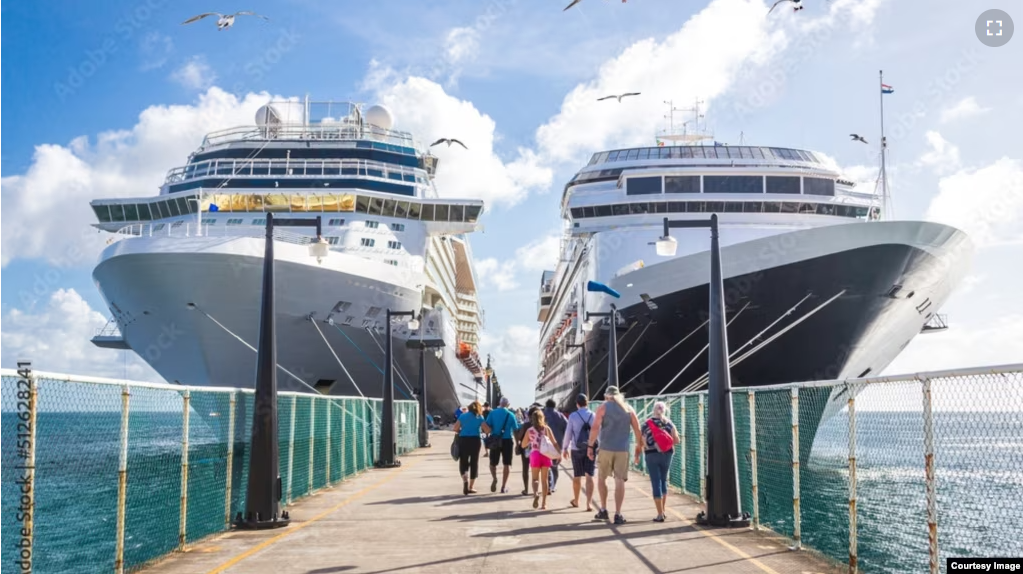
(572, 202, 872, 219)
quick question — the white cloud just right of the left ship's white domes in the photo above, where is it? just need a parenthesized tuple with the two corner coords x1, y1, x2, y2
(365, 63, 553, 209)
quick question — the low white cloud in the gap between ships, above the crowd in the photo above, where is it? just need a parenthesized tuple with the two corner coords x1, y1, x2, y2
(480, 324, 540, 406)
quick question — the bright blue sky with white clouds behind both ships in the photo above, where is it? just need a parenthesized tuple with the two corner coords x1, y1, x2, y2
(0, 0, 1023, 403)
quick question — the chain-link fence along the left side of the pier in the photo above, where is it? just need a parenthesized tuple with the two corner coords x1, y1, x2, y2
(0, 369, 418, 574)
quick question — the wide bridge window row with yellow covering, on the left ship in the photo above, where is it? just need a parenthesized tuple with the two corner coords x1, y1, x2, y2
(92, 193, 483, 223)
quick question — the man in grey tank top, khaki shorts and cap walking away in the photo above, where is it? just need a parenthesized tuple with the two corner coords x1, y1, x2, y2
(586, 387, 642, 524)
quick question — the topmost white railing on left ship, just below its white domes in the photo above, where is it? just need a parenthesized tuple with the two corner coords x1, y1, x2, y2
(198, 122, 416, 151)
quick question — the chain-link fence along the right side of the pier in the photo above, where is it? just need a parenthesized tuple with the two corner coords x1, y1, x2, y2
(609, 364, 1023, 574)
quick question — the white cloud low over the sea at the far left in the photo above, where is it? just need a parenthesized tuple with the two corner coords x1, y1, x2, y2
(0, 289, 163, 382)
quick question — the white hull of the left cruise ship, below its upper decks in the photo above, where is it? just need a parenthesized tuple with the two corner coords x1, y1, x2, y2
(93, 237, 477, 416)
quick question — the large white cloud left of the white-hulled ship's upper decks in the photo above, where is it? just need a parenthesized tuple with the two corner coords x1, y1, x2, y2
(0, 88, 269, 266)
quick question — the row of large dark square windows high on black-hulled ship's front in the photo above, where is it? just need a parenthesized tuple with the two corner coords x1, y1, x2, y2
(625, 175, 835, 195)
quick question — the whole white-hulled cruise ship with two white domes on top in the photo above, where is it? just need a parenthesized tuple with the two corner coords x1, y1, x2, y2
(91, 98, 485, 416)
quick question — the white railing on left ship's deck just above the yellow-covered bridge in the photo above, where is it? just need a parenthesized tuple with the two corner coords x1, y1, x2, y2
(164, 159, 430, 185)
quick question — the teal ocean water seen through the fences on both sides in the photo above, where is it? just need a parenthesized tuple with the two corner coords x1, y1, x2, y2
(0, 412, 1023, 574)
